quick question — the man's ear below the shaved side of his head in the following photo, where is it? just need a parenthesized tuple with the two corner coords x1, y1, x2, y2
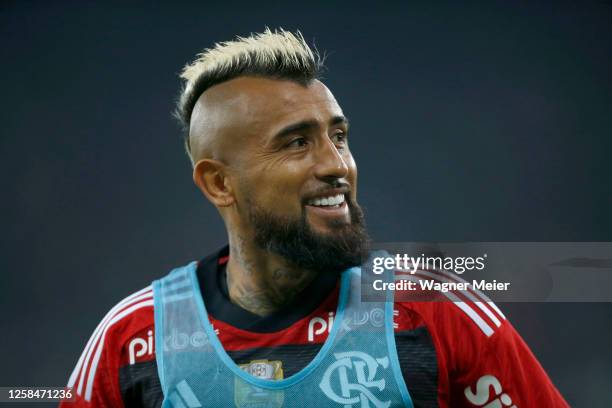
(193, 159, 236, 207)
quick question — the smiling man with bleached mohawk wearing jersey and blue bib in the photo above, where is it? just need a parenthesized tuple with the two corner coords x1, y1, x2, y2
(63, 30, 567, 407)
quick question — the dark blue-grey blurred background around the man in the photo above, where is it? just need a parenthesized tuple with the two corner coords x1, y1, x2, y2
(0, 1, 612, 407)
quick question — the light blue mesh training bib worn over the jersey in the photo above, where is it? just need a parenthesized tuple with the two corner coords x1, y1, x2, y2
(153, 262, 413, 408)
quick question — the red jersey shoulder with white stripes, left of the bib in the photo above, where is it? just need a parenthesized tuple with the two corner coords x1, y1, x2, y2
(68, 286, 154, 403)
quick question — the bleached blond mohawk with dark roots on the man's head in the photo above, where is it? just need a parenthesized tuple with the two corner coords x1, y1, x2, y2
(174, 27, 324, 163)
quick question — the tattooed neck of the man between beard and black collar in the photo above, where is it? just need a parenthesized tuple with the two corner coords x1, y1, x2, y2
(227, 235, 316, 317)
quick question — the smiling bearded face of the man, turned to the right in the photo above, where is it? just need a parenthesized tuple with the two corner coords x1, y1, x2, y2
(192, 77, 367, 268)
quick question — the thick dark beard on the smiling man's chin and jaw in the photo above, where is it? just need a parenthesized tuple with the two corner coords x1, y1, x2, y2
(249, 197, 370, 273)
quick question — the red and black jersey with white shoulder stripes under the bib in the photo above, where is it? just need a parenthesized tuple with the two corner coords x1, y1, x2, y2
(60, 247, 568, 408)
